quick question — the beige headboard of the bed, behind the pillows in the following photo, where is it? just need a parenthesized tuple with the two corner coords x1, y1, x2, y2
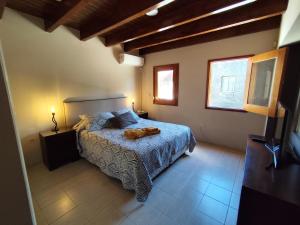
(64, 96, 129, 127)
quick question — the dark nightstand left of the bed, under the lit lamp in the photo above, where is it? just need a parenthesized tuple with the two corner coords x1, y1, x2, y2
(40, 129, 80, 170)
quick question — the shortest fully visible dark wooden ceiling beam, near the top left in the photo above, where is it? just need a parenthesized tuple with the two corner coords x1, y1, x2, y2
(45, 0, 89, 32)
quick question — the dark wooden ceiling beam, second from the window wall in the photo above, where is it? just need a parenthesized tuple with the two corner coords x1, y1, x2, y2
(124, 0, 287, 52)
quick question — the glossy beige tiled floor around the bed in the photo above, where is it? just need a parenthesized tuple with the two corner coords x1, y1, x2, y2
(29, 144, 244, 225)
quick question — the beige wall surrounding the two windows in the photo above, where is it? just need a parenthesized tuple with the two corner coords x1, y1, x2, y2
(142, 30, 278, 149)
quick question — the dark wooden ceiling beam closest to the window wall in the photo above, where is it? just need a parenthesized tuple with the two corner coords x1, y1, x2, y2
(139, 16, 281, 55)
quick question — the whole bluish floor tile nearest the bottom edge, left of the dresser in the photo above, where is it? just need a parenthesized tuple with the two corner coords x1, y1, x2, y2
(198, 196, 228, 223)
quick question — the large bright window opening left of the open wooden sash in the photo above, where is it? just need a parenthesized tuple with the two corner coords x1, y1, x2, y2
(206, 56, 251, 111)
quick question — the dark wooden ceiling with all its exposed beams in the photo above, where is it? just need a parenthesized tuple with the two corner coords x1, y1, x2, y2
(0, 0, 288, 54)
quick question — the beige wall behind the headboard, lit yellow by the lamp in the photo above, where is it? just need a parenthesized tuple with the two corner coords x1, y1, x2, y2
(0, 8, 140, 165)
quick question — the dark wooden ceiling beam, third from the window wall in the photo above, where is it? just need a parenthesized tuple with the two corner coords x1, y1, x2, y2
(105, 0, 243, 46)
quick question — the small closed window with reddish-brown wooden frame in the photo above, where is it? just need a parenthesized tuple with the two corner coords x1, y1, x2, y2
(153, 64, 179, 106)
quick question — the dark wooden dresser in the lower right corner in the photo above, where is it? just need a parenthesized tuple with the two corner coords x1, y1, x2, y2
(237, 138, 300, 225)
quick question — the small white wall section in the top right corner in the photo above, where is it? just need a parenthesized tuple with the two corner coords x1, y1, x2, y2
(279, 0, 300, 46)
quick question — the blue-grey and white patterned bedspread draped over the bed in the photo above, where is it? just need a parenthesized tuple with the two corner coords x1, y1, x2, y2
(78, 119, 196, 201)
